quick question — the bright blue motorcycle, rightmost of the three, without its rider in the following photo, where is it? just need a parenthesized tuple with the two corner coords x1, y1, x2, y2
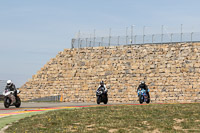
(138, 89, 150, 104)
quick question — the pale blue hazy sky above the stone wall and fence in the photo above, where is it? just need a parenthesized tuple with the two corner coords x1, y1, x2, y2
(0, 0, 200, 87)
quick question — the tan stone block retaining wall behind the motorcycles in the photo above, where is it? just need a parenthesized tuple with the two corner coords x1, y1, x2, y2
(20, 43, 200, 103)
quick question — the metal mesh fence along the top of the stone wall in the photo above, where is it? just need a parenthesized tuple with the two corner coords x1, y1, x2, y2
(71, 32, 200, 48)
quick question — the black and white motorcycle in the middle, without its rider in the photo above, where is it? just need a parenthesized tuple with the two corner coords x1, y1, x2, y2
(96, 87, 108, 104)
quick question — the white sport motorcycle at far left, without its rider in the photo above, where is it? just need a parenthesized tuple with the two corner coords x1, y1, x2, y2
(3, 89, 21, 108)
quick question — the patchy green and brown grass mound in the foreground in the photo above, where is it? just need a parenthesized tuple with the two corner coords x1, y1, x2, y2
(6, 103, 200, 133)
